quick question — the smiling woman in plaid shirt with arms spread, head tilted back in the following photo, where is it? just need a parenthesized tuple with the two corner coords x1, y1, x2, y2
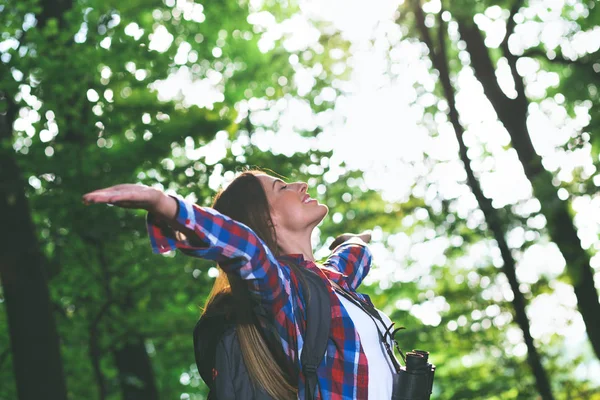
(83, 171, 396, 400)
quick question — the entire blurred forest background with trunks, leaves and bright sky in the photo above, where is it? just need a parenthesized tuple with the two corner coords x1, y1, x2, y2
(0, 0, 600, 400)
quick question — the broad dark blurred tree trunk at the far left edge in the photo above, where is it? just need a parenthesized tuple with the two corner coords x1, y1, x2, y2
(0, 93, 67, 400)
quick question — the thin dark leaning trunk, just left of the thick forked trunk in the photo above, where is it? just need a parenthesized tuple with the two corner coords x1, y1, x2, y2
(413, 0, 554, 400)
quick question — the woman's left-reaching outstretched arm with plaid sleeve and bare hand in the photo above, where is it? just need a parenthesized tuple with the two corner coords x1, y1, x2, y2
(83, 184, 290, 308)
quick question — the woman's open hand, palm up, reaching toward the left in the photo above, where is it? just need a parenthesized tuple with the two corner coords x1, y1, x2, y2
(82, 183, 167, 212)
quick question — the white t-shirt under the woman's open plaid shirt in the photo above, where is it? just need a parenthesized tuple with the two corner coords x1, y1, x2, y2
(335, 292, 394, 400)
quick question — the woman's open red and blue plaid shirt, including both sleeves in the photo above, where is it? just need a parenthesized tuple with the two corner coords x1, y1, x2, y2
(147, 199, 371, 400)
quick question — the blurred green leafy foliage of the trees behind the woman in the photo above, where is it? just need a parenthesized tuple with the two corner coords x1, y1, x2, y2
(0, 0, 600, 400)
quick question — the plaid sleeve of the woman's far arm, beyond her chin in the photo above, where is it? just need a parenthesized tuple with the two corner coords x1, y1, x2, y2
(324, 238, 371, 290)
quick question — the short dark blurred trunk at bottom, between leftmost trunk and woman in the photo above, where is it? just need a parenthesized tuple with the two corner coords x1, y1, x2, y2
(113, 336, 158, 400)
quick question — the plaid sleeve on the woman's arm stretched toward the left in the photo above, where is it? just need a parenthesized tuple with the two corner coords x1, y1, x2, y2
(146, 197, 290, 309)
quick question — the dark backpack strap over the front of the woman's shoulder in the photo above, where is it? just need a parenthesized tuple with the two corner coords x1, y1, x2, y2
(300, 268, 331, 400)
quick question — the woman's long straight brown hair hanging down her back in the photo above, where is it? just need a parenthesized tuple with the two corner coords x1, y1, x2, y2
(203, 170, 301, 400)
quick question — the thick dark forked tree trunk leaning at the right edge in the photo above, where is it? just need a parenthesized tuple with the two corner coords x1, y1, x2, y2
(458, 1, 600, 358)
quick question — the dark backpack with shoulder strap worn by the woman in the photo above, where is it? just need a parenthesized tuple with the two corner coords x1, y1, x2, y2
(194, 268, 331, 400)
